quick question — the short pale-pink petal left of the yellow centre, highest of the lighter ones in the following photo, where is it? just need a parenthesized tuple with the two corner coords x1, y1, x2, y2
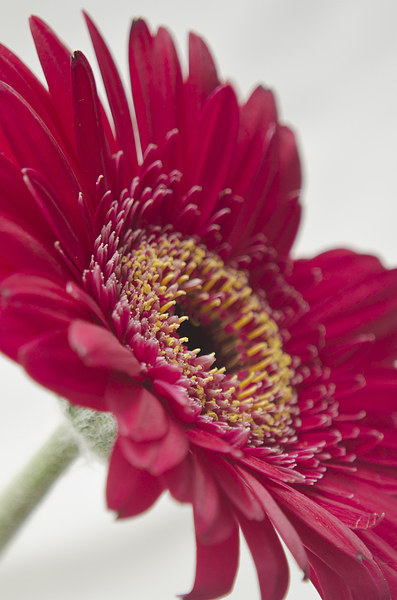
(68, 321, 140, 377)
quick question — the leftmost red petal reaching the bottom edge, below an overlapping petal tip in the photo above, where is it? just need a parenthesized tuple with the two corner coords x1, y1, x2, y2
(182, 526, 239, 600)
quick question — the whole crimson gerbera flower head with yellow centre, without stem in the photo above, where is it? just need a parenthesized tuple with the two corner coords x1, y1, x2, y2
(0, 10, 397, 600)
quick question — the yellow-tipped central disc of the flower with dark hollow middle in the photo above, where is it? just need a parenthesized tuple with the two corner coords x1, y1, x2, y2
(121, 230, 297, 446)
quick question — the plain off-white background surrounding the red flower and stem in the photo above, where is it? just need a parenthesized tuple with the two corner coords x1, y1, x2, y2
(0, 0, 397, 600)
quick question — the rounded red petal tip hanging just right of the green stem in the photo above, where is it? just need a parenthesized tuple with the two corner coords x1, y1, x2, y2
(106, 441, 163, 518)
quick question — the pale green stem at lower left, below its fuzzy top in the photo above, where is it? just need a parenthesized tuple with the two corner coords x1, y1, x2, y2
(0, 423, 79, 552)
